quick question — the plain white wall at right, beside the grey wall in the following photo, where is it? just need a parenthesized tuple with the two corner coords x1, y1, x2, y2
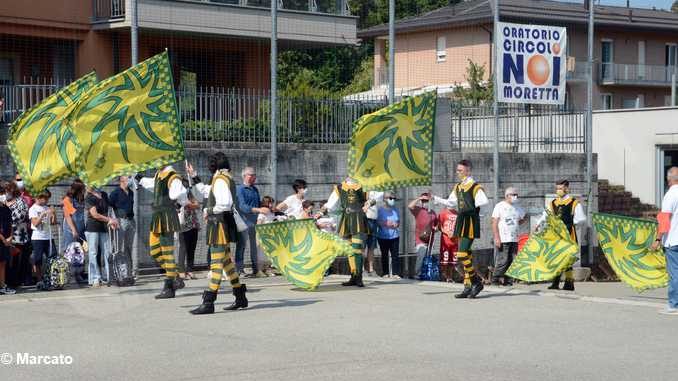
(593, 107, 678, 204)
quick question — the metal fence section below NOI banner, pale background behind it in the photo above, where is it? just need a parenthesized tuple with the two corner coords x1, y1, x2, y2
(451, 104, 586, 153)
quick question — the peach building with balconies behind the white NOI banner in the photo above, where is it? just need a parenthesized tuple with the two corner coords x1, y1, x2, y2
(358, 0, 678, 109)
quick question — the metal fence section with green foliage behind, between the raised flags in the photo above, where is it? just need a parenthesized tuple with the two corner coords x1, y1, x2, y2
(177, 88, 387, 144)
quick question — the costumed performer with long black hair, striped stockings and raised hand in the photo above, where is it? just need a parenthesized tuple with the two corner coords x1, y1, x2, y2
(186, 152, 248, 315)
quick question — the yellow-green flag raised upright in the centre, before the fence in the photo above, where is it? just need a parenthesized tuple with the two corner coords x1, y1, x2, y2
(348, 92, 436, 190)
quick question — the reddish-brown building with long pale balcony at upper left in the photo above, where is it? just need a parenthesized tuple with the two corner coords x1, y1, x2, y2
(0, 0, 357, 84)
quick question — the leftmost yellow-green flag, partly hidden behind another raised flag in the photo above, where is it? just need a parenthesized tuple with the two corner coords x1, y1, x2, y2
(7, 73, 97, 194)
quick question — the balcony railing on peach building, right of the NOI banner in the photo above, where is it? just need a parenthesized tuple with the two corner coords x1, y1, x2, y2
(598, 62, 675, 86)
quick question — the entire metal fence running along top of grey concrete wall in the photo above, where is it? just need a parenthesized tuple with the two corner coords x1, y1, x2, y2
(0, 80, 585, 153)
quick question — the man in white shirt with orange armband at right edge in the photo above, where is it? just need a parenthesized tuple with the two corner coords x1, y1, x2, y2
(652, 167, 678, 316)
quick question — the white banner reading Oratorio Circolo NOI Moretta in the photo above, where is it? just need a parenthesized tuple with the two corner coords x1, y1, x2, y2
(495, 22, 567, 105)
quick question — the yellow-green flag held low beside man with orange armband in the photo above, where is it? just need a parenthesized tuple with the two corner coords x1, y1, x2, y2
(593, 213, 669, 292)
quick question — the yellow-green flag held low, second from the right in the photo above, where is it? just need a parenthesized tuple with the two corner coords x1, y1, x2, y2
(506, 213, 579, 282)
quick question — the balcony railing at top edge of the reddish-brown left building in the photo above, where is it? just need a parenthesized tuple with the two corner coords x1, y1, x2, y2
(92, 0, 351, 21)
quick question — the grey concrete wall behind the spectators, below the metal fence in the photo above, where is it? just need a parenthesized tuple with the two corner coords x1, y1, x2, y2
(0, 143, 597, 266)
